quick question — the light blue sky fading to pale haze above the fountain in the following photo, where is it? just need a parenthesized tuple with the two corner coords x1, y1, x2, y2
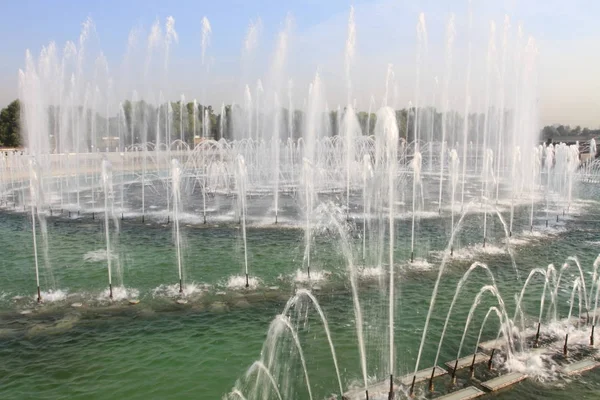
(0, 0, 600, 128)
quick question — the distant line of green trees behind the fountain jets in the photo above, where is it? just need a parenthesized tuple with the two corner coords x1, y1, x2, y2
(0, 100, 600, 149)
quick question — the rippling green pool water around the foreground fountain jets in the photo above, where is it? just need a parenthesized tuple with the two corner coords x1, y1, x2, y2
(0, 186, 600, 399)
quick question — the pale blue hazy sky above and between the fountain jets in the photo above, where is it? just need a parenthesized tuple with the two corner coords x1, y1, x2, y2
(0, 0, 600, 126)
